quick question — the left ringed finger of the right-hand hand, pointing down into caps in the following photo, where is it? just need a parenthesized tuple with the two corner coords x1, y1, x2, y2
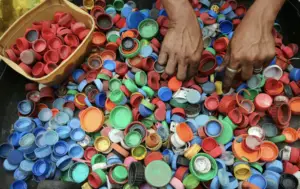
(223, 58, 239, 93)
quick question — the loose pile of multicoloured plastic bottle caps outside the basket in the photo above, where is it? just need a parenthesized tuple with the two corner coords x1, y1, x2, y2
(0, 0, 300, 189)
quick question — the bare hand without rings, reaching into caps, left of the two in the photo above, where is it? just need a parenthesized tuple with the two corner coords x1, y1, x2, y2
(158, 0, 203, 80)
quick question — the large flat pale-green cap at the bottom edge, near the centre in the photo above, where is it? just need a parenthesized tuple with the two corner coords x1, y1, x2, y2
(145, 160, 172, 187)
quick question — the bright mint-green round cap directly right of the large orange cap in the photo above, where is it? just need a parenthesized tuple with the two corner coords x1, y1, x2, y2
(109, 106, 133, 130)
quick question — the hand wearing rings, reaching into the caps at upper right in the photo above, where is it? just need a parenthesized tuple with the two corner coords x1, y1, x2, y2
(217, 0, 285, 93)
